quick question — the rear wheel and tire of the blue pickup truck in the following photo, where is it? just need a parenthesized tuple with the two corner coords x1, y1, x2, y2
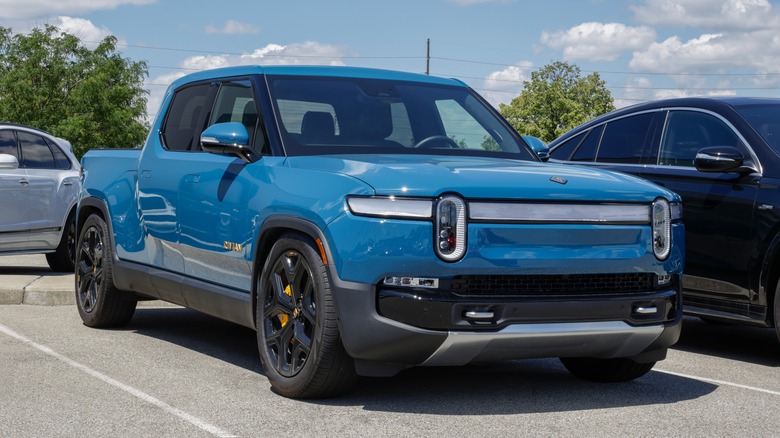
(76, 214, 138, 328)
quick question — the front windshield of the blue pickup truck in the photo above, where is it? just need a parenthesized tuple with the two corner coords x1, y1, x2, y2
(267, 76, 536, 160)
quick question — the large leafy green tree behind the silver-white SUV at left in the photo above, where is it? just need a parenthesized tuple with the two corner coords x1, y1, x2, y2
(0, 25, 148, 158)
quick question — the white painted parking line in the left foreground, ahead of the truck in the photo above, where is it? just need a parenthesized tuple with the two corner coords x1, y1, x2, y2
(0, 324, 236, 438)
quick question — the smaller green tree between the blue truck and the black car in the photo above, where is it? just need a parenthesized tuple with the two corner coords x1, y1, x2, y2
(499, 61, 615, 142)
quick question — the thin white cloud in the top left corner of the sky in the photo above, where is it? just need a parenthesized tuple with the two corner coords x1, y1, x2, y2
(0, 0, 157, 20)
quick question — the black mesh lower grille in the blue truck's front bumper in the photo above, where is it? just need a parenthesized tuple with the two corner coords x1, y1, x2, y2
(450, 273, 655, 297)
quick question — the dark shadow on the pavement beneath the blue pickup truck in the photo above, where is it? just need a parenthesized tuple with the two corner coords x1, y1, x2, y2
(121, 307, 717, 415)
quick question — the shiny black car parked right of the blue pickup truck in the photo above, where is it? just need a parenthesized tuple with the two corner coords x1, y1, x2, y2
(549, 98, 780, 344)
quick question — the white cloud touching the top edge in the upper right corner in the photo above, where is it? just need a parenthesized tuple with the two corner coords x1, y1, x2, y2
(631, 0, 780, 31)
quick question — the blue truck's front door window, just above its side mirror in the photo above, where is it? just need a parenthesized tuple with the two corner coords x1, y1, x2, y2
(209, 80, 265, 151)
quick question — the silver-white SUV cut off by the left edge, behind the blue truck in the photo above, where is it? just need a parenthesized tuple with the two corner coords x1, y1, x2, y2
(0, 123, 81, 272)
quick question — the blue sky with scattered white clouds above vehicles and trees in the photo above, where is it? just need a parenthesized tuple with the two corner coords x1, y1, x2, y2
(0, 0, 780, 116)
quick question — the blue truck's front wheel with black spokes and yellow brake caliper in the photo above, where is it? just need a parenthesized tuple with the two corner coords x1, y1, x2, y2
(256, 234, 357, 399)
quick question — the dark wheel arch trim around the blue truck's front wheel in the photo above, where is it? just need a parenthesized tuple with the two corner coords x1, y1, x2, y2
(251, 215, 335, 328)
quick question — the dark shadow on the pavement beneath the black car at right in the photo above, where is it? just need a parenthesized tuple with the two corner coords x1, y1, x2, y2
(672, 316, 780, 367)
